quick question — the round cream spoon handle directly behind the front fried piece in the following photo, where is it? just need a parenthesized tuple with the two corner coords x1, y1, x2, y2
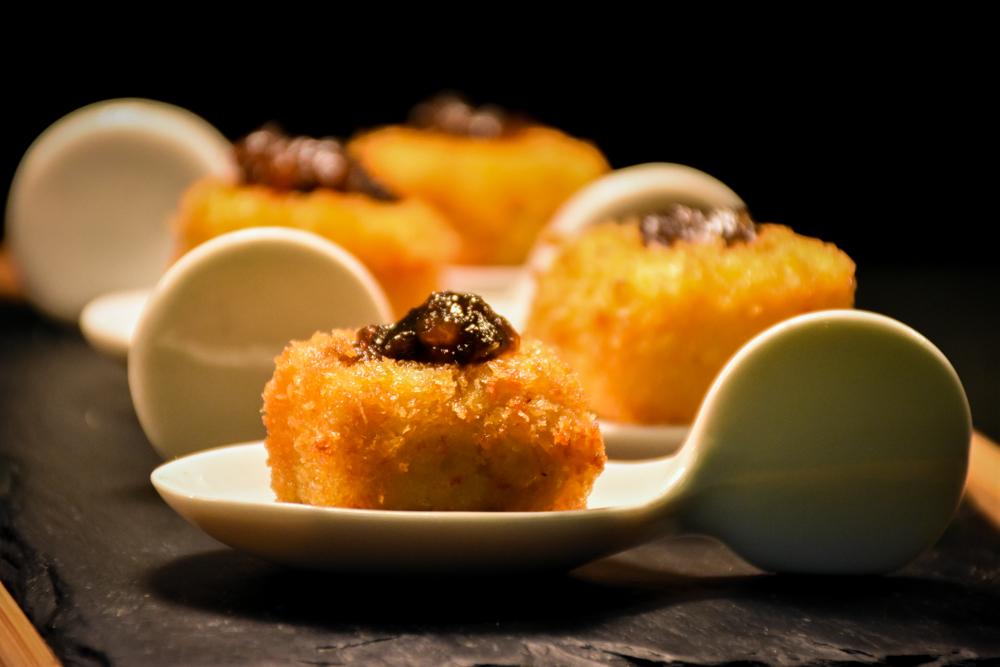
(128, 227, 392, 458)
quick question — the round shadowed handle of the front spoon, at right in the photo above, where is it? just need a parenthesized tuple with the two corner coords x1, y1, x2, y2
(654, 310, 971, 573)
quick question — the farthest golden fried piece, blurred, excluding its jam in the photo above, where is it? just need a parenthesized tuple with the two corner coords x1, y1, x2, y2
(348, 126, 609, 264)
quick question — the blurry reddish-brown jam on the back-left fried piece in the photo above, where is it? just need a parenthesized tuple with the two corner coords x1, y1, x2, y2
(235, 125, 396, 201)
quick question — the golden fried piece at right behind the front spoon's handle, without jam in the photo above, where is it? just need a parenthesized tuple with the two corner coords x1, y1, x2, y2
(525, 223, 855, 424)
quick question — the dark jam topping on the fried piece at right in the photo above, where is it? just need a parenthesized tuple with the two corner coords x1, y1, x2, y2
(639, 204, 757, 246)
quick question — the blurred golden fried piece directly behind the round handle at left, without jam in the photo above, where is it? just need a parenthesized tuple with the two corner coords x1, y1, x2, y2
(176, 180, 458, 314)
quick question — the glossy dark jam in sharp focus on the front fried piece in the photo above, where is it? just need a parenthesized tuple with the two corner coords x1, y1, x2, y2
(354, 292, 520, 364)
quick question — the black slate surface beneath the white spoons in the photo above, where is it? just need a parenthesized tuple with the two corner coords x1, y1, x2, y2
(0, 271, 1000, 665)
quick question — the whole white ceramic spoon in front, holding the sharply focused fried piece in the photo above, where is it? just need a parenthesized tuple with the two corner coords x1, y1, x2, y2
(152, 311, 971, 574)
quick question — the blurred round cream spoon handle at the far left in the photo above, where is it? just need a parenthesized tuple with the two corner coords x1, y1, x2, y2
(7, 99, 236, 321)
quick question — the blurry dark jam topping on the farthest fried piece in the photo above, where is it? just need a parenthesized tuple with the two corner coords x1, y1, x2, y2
(410, 93, 530, 139)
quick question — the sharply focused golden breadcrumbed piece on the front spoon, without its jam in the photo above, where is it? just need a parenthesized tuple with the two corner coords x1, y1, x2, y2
(264, 330, 605, 510)
